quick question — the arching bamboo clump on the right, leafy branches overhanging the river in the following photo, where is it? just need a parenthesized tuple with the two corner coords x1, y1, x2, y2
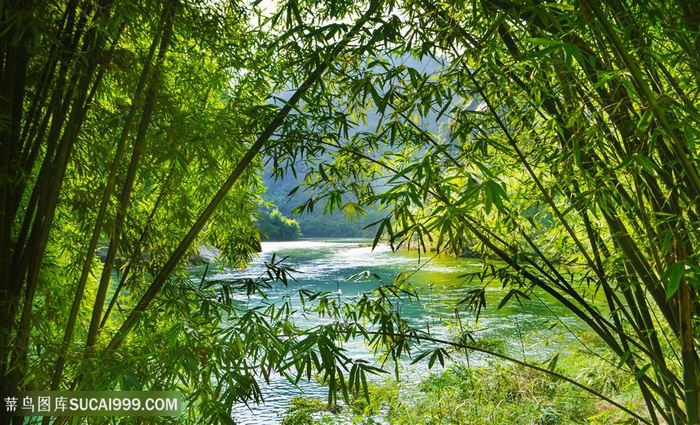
(267, 0, 700, 424)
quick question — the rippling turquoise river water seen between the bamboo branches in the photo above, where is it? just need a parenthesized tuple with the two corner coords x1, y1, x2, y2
(210, 240, 583, 424)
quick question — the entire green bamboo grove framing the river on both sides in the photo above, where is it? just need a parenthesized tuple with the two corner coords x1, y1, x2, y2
(0, 0, 700, 424)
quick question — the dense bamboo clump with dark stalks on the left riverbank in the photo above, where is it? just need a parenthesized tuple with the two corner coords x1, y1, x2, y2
(0, 0, 394, 423)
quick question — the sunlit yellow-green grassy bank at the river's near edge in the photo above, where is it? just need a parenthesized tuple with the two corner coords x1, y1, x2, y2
(283, 355, 643, 425)
